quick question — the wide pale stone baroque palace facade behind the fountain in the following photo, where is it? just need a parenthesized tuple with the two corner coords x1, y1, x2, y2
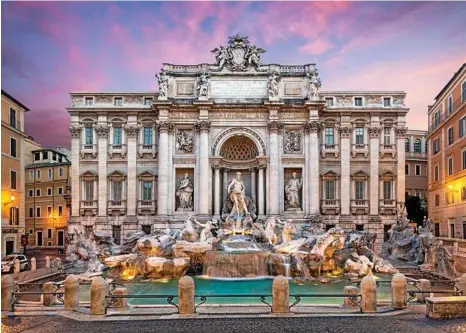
(68, 35, 408, 248)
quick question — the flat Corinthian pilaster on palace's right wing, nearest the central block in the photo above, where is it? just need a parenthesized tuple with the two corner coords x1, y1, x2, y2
(339, 126, 353, 215)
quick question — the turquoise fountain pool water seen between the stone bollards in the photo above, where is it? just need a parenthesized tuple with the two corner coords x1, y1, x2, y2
(80, 275, 391, 305)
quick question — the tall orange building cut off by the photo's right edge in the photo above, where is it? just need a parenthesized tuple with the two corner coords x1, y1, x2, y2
(427, 63, 466, 239)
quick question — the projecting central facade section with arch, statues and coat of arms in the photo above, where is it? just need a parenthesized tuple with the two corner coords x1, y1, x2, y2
(157, 35, 325, 224)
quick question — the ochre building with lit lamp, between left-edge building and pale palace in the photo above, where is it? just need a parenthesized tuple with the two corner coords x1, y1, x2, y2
(25, 149, 71, 254)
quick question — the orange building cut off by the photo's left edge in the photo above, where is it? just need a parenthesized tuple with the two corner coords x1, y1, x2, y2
(1, 89, 29, 257)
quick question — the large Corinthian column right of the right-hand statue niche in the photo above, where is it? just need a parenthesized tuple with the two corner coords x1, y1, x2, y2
(306, 121, 321, 215)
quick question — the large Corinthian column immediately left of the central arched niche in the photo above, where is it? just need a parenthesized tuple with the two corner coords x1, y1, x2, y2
(196, 120, 211, 215)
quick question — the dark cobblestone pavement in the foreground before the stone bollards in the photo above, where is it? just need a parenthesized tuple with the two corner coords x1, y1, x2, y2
(1, 314, 466, 333)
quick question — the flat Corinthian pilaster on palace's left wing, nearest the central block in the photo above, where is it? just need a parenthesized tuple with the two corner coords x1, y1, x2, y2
(125, 125, 139, 216)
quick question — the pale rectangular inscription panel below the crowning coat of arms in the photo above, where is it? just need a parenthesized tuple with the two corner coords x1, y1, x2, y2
(210, 80, 268, 98)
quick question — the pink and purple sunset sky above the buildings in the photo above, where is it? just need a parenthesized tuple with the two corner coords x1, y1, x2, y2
(1, 2, 466, 147)
